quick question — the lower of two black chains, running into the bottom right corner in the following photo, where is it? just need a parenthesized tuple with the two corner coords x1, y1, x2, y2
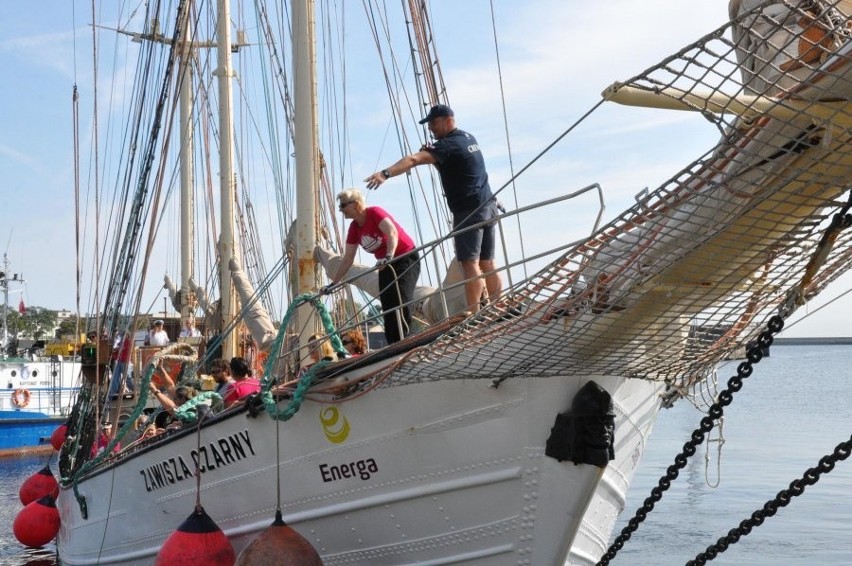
(686, 437, 852, 566)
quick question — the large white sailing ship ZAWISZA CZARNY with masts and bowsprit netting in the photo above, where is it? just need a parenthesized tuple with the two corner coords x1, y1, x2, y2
(48, 0, 852, 565)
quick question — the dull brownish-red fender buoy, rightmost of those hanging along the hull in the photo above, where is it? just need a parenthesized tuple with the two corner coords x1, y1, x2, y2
(237, 511, 322, 566)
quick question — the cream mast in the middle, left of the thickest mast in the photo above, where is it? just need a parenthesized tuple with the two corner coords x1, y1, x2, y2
(215, 0, 239, 360)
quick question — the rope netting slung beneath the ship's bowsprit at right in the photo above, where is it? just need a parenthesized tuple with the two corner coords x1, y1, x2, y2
(368, 2, 852, 394)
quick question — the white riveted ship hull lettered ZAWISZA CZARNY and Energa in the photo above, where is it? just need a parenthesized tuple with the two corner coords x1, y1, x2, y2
(58, 370, 659, 564)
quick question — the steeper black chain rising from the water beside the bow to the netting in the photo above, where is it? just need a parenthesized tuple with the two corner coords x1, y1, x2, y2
(598, 315, 784, 566)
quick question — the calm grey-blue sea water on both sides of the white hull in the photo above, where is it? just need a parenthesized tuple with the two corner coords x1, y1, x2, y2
(0, 345, 852, 566)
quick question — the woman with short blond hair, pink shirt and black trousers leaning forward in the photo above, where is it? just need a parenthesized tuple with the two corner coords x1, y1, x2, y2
(324, 189, 420, 344)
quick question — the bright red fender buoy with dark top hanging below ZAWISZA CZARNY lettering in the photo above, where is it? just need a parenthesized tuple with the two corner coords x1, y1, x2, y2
(154, 505, 237, 566)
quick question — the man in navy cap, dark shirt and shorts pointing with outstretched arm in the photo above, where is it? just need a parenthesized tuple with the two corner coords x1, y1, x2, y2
(364, 104, 503, 311)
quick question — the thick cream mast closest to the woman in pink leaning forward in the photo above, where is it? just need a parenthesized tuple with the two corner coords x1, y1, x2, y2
(293, 0, 319, 342)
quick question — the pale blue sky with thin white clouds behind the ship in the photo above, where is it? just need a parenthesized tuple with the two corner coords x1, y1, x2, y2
(0, 0, 852, 336)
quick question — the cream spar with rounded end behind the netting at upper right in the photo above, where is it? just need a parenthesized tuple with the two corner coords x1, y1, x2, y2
(601, 83, 852, 127)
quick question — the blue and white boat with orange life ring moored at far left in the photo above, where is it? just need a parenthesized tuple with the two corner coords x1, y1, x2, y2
(0, 254, 80, 457)
